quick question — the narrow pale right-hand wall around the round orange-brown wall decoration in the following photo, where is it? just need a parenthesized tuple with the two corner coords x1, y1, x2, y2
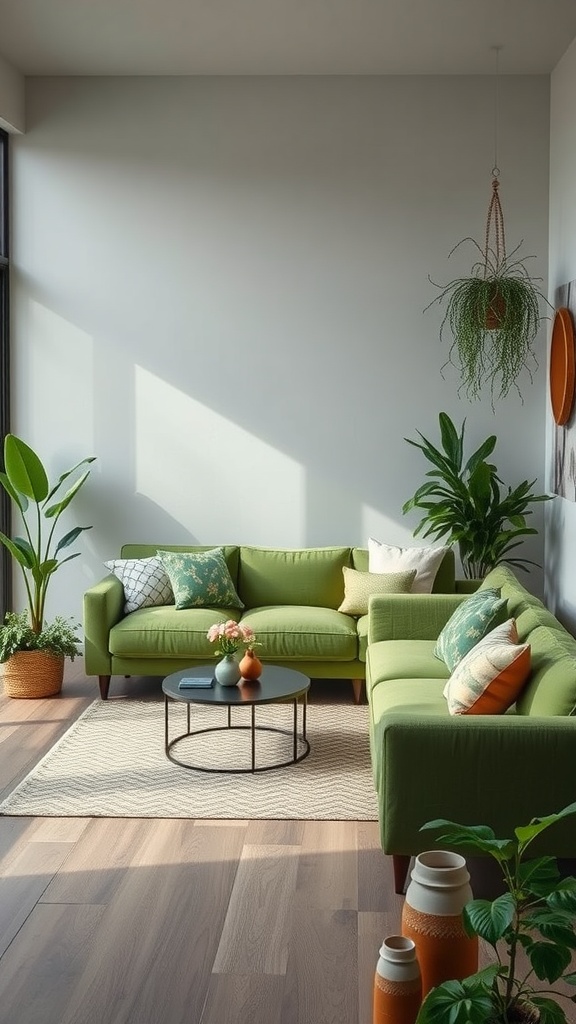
(546, 40, 576, 632)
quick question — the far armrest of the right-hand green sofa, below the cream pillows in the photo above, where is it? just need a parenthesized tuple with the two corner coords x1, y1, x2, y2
(368, 594, 467, 644)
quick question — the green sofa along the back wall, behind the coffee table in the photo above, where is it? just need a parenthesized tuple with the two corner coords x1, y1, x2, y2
(84, 544, 456, 701)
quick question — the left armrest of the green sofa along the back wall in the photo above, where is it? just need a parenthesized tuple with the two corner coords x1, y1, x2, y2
(84, 573, 124, 676)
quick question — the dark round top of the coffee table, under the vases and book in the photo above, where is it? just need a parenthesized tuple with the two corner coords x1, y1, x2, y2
(162, 665, 310, 706)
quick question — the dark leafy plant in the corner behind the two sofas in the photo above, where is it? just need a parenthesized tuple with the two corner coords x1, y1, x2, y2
(402, 413, 551, 579)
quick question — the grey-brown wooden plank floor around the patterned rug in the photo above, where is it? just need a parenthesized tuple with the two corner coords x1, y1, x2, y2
(0, 662, 576, 1024)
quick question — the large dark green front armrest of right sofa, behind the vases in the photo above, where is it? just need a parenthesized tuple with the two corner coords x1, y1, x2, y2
(374, 712, 576, 857)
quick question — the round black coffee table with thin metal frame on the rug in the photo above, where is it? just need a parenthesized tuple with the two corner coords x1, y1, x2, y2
(162, 665, 310, 774)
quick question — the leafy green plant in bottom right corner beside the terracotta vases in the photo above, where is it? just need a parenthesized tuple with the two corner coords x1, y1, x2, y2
(417, 803, 576, 1024)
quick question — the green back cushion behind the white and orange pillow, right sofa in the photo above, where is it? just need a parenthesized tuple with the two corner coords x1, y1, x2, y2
(517, 626, 576, 716)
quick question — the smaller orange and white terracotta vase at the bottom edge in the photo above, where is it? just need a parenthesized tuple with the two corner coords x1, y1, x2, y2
(372, 935, 422, 1024)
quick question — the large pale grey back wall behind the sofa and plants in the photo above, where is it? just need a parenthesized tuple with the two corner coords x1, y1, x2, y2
(8, 77, 549, 614)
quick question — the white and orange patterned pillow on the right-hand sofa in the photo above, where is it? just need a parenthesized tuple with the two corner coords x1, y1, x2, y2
(447, 627, 531, 715)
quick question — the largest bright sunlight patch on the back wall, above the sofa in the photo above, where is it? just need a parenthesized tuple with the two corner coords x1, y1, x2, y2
(134, 366, 305, 547)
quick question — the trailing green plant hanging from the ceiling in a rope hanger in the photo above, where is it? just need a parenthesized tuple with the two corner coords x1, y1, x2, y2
(425, 174, 549, 401)
